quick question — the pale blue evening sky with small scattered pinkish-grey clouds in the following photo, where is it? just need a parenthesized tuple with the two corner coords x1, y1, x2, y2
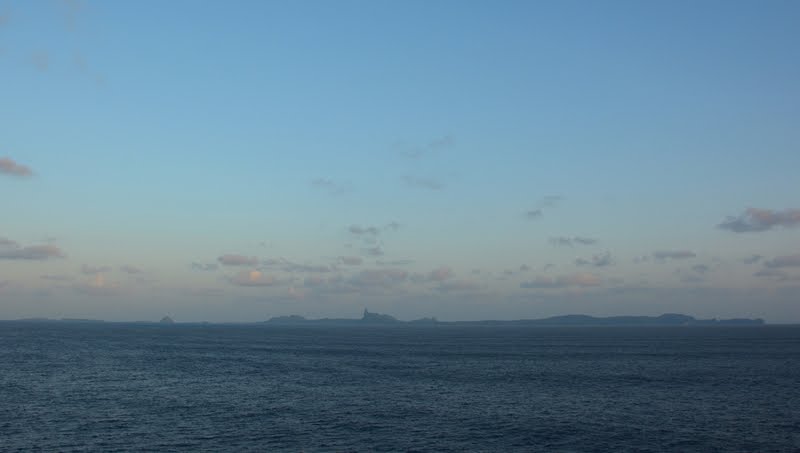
(0, 0, 800, 323)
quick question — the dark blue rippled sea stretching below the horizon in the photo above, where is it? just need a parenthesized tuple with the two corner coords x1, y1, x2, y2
(0, 322, 800, 452)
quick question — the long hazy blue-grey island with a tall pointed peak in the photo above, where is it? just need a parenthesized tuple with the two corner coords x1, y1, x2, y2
(264, 309, 765, 326)
